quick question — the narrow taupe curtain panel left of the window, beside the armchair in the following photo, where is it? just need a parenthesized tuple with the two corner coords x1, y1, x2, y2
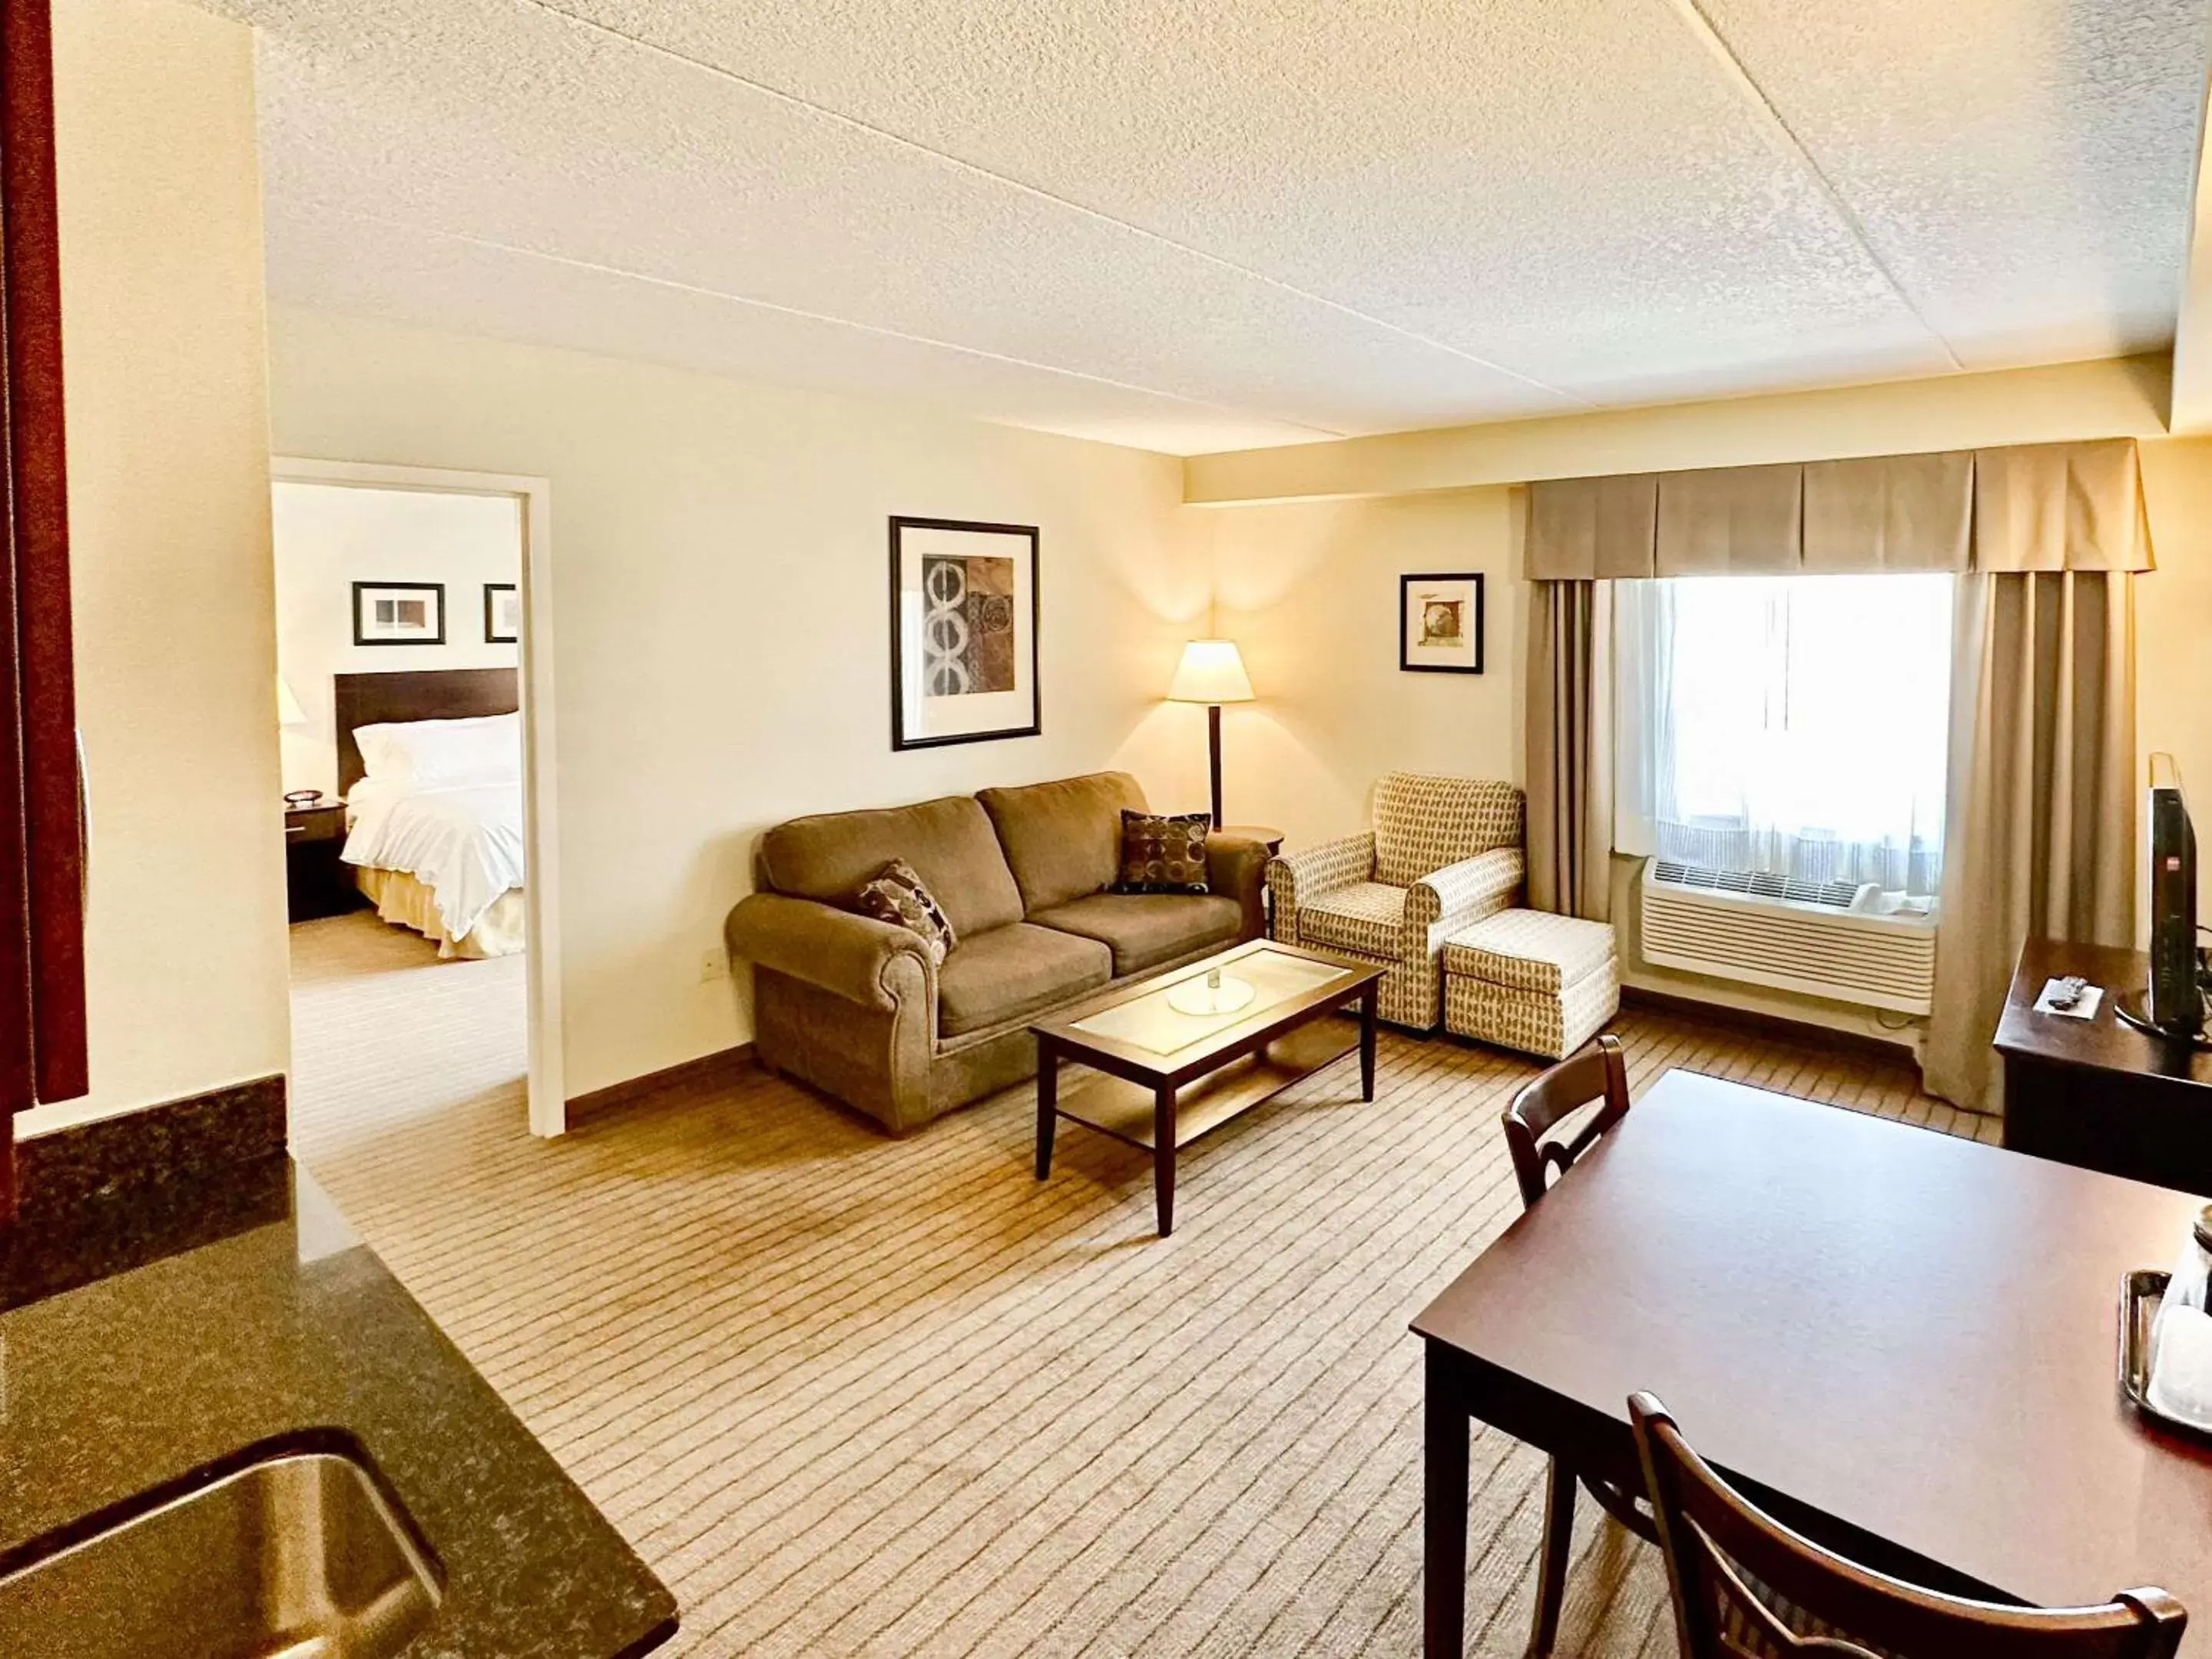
(1526, 581, 1613, 922)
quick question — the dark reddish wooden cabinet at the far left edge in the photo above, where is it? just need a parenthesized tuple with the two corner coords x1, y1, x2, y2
(0, 0, 91, 1221)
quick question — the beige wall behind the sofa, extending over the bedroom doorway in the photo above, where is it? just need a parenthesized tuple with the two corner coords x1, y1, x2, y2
(272, 307, 1207, 1095)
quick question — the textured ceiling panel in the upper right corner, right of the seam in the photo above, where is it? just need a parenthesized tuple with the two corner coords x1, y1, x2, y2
(1701, 0, 2205, 367)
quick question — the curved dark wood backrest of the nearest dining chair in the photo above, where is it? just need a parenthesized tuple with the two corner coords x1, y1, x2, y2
(1628, 1393, 2187, 1659)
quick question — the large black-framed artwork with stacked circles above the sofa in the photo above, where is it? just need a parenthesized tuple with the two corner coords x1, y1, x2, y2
(892, 518, 1044, 750)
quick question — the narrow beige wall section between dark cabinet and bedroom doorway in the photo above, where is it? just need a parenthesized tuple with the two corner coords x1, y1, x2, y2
(20, 0, 290, 1133)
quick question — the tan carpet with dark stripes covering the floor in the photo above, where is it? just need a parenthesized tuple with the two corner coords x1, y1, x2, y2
(280, 916, 1995, 1659)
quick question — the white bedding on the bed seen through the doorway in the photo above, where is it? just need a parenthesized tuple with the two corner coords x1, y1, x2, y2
(343, 777, 522, 940)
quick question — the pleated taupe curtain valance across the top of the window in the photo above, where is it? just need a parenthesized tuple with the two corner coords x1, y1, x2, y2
(1528, 438, 2152, 581)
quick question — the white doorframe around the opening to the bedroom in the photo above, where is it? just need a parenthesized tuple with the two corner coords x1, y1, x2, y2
(270, 455, 568, 1137)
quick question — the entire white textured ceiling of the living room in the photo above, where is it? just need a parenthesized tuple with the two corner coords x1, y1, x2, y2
(199, 0, 2212, 453)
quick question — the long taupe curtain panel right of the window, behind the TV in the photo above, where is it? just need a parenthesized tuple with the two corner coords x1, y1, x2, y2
(1922, 575, 2134, 1113)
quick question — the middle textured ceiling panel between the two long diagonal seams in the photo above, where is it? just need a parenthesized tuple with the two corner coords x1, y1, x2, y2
(553, 0, 1946, 398)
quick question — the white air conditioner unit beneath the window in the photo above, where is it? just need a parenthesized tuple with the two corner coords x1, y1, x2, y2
(1641, 858, 1936, 1013)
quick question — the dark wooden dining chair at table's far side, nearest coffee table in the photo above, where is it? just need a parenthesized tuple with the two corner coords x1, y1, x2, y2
(1506, 1038, 1659, 1659)
